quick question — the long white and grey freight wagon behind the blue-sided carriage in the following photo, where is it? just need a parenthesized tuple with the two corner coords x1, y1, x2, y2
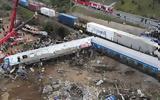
(86, 22, 158, 55)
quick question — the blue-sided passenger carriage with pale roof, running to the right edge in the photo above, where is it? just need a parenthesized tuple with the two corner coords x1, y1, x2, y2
(91, 37, 160, 79)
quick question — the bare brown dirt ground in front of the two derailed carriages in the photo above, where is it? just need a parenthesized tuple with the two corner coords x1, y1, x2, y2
(0, 52, 160, 100)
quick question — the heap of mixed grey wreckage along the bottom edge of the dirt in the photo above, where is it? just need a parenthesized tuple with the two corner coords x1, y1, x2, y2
(42, 80, 150, 100)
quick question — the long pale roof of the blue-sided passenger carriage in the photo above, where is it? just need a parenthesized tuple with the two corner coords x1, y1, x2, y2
(92, 37, 160, 70)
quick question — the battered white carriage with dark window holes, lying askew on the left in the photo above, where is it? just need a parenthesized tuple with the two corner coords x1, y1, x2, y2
(4, 37, 93, 66)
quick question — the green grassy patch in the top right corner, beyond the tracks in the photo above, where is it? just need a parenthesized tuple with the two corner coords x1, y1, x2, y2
(115, 0, 160, 19)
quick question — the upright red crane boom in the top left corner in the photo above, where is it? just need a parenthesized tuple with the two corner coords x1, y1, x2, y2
(9, 0, 19, 32)
